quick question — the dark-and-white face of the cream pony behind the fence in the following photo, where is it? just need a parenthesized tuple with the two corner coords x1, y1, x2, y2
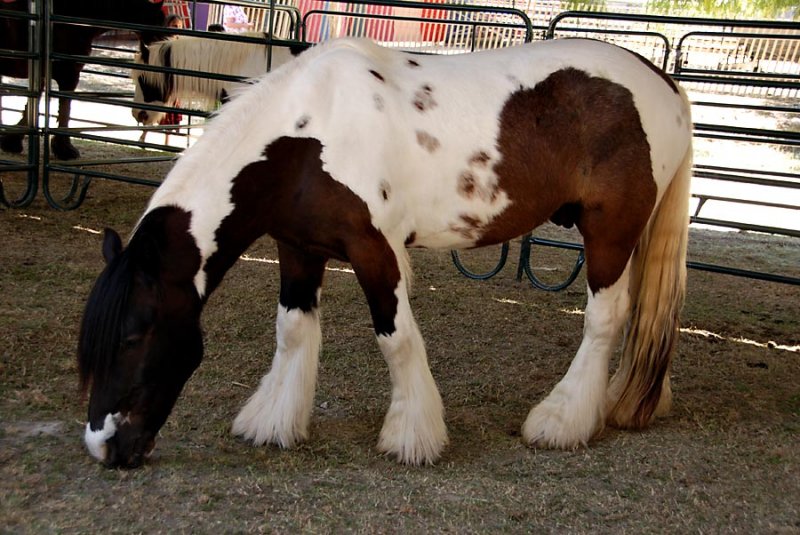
(131, 42, 174, 125)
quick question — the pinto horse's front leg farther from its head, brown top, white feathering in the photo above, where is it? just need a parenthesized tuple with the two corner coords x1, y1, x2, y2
(348, 236, 447, 465)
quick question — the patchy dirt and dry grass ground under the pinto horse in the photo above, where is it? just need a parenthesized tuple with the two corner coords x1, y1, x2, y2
(0, 140, 800, 533)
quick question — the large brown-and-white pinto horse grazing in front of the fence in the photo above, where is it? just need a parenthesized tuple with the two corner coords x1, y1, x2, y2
(78, 38, 692, 467)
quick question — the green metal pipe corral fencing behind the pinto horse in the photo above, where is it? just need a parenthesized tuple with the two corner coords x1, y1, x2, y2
(0, 0, 800, 290)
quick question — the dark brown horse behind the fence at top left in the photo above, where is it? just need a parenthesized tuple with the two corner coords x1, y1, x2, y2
(0, 0, 164, 160)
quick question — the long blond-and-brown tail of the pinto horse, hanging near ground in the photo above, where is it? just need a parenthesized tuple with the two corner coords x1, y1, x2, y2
(607, 100, 692, 429)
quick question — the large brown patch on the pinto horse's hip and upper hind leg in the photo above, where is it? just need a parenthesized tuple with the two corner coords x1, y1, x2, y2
(477, 68, 657, 291)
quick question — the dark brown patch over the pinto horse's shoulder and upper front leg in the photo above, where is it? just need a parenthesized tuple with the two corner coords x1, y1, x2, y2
(205, 137, 401, 335)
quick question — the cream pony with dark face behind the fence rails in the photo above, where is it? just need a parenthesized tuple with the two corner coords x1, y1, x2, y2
(131, 33, 308, 125)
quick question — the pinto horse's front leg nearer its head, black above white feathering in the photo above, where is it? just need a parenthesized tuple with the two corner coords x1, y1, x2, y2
(233, 243, 326, 448)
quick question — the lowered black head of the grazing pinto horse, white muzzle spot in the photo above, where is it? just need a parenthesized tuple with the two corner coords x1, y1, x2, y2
(78, 220, 203, 468)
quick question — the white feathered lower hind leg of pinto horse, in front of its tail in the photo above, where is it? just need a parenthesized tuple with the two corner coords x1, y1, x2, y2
(522, 264, 630, 448)
